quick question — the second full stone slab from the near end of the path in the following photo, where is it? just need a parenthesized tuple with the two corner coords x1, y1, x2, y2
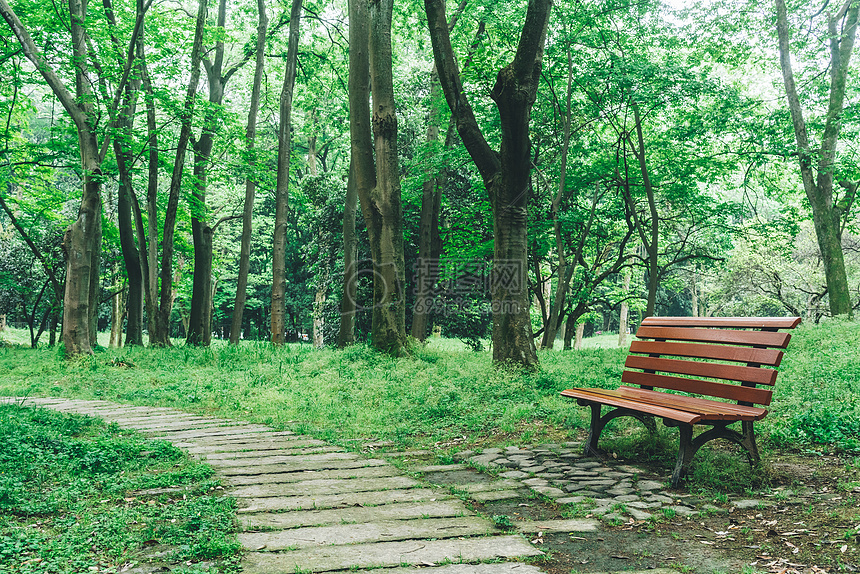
(238, 516, 493, 551)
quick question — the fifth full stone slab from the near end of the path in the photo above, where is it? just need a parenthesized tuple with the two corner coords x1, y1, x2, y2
(228, 476, 418, 498)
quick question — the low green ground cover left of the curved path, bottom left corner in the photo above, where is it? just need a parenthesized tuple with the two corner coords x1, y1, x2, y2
(0, 405, 239, 574)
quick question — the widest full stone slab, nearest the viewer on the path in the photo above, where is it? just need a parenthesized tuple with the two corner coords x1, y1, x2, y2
(242, 536, 543, 574)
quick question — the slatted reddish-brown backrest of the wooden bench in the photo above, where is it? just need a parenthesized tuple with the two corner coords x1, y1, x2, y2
(621, 317, 800, 405)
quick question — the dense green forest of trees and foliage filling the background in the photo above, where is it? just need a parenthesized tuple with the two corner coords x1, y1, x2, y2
(0, 0, 860, 365)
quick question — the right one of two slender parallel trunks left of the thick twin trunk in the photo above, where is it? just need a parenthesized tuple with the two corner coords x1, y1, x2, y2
(271, 0, 302, 345)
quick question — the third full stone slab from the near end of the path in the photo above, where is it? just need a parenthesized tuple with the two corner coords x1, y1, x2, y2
(239, 499, 474, 530)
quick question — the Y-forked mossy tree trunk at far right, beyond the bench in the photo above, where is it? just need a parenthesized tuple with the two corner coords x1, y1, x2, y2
(775, 0, 860, 317)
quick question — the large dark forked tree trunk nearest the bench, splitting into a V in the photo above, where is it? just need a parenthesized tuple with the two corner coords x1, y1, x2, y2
(424, 0, 552, 366)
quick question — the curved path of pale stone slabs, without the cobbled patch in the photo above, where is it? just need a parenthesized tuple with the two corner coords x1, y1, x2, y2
(0, 398, 548, 574)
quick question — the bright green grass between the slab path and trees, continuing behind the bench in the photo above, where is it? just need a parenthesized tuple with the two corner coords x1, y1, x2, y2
(0, 321, 860, 472)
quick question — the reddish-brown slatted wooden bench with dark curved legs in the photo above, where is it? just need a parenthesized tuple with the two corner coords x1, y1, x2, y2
(561, 317, 800, 486)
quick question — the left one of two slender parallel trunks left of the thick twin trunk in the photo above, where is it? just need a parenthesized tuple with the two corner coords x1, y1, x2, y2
(230, 0, 269, 345)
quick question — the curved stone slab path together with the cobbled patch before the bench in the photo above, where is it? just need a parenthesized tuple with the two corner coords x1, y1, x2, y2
(5, 398, 761, 574)
